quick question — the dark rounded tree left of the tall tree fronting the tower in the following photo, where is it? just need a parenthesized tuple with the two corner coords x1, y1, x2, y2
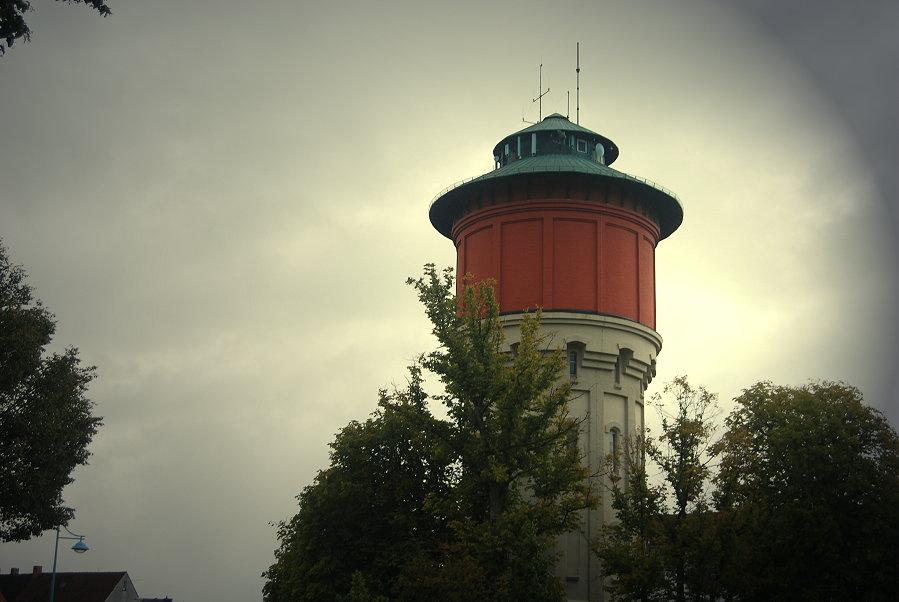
(263, 366, 452, 602)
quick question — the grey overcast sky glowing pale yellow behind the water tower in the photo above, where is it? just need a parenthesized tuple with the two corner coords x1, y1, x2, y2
(0, 0, 899, 602)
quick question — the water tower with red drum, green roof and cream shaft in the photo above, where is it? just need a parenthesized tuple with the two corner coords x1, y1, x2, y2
(430, 114, 683, 601)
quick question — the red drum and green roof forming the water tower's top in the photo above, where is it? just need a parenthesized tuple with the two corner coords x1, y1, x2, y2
(430, 114, 683, 329)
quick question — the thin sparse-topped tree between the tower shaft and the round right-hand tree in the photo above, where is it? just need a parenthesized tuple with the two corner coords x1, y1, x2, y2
(596, 376, 718, 601)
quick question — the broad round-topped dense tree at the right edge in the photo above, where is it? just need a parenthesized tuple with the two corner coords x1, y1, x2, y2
(715, 382, 899, 600)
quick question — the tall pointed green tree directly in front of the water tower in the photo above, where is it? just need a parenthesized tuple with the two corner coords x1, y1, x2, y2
(409, 265, 595, 600)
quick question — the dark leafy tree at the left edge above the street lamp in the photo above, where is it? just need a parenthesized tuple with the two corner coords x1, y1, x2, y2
(0, 239, 101, 541)
